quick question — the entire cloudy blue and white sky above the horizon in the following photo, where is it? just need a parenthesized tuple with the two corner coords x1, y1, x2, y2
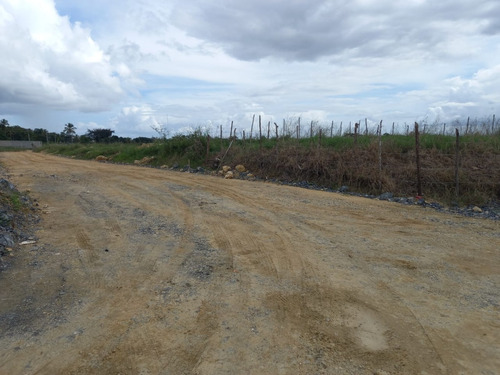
(0, 0, 500, 137)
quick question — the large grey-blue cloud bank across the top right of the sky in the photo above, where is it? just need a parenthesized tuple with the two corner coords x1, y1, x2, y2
(172, 0, 500, 61)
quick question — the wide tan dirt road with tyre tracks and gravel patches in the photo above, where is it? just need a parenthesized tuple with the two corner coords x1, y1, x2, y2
(0, 152, 500, 375)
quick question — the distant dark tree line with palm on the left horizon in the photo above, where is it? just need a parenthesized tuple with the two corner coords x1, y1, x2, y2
(0, 119, 154, 143)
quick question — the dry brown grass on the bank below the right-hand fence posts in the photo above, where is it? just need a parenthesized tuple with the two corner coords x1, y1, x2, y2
(227, 136, 500, 204)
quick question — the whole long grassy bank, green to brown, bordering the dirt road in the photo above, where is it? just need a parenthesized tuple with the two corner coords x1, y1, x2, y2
(34, 125, 500, 205)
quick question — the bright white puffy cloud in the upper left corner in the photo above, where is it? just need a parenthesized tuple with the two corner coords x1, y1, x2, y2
(0, 0, 123, 111)
